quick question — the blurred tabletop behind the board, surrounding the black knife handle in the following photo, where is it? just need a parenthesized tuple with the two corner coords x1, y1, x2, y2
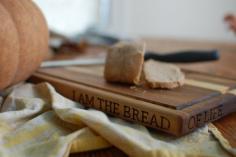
(143, 38, 236, 80)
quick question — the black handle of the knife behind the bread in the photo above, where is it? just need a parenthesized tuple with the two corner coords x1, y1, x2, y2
(145, 50, 220, 63)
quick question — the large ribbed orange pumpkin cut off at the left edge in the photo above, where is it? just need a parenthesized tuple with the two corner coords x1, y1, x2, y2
(0, 0, 49, 90)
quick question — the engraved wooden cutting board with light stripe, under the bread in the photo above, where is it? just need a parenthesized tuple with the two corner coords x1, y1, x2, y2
(30, 65, 236, 136)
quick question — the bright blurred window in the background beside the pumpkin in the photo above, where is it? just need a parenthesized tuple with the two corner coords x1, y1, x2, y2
(34, 0, 99, 36)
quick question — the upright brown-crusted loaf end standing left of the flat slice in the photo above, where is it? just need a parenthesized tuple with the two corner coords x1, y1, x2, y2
(104, 42, 145, 84)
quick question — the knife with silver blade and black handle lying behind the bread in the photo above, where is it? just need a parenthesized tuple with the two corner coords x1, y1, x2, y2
(40, 50, 219, 68)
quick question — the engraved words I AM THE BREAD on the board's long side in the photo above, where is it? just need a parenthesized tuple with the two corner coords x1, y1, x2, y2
(73, 91, 171, 130)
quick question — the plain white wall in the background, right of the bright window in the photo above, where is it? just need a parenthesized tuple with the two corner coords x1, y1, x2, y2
(108, 0, 236, 42)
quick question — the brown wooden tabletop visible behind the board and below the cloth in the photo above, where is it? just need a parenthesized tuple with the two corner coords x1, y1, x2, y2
(59, 38, 236, 157)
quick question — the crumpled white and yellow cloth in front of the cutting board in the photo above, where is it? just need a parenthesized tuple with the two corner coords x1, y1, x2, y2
(0, 83, 236, 157)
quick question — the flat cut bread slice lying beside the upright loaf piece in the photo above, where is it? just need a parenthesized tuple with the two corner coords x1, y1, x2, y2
(144, 60, 185, 89)
